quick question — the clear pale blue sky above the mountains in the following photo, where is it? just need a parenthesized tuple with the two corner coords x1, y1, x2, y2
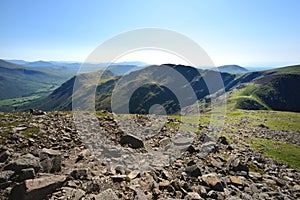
(0, 0, 300, 66)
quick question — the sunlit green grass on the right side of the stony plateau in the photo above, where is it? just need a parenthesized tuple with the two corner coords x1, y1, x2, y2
(173, 109, 300, 169)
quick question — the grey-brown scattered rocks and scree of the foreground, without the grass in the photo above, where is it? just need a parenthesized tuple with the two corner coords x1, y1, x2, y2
(0, 112, 300, 200)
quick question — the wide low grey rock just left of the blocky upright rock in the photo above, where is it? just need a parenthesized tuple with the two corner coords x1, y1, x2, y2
(4, 154, 41, 173)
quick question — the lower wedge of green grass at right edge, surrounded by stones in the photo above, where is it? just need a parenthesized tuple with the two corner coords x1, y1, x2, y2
(246, 138, 300, 169)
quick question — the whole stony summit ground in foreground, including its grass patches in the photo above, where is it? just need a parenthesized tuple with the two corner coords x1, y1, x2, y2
(0, 110, 300, 200)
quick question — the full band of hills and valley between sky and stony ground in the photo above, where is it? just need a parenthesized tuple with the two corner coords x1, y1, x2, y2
(0, 60, 300, 114)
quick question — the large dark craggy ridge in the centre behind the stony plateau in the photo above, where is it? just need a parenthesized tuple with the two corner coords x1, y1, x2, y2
(30, 64, 235, 114)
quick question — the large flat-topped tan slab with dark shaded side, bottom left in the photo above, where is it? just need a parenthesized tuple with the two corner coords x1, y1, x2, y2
(9, 175, 66, 200)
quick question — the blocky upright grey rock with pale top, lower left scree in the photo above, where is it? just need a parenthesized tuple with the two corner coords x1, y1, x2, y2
(40, 148, 62, 173)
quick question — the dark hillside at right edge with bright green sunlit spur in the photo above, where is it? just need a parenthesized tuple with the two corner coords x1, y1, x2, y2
(229, 65, 300, 112)
